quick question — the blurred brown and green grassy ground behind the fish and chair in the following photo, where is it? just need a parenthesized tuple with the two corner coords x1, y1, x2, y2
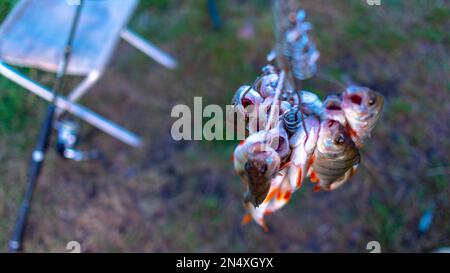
(0, 0, 450, 252)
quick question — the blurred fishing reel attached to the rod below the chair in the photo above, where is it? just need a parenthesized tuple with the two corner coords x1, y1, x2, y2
(55, 119, 100, 161)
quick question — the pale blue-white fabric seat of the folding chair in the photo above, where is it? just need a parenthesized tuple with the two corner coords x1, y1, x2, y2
(0, 0, 138, 76)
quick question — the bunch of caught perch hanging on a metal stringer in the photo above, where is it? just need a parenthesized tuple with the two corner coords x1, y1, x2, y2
(233, 0, 384, 230)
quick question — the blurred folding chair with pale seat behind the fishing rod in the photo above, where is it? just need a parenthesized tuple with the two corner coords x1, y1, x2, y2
(0, 0, 177, 147)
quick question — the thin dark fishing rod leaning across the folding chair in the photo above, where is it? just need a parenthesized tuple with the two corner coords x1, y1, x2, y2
(9, 0, 84, 252)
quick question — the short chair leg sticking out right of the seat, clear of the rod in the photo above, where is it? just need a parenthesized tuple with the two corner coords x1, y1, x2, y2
(120, 29, 178, 69)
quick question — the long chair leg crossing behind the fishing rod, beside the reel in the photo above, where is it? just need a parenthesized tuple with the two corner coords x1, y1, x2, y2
(0, 61, 142, 147)
